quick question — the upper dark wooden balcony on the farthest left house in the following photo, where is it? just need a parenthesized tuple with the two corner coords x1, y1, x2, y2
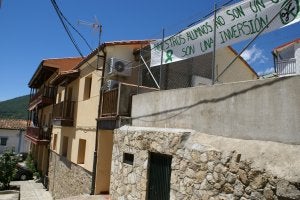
(29, 86, 56, 110)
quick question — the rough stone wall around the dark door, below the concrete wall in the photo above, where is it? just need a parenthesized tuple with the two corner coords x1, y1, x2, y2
(110, 127, 300, 200)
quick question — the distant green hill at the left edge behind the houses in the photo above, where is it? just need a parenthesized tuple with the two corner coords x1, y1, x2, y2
(0, 95, 29, 119)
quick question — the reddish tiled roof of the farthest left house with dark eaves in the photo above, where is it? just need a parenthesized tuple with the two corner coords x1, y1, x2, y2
(28, 57, 83, 86)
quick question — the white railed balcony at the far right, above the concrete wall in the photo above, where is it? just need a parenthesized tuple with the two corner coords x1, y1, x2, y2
(275, 58, 297, 76)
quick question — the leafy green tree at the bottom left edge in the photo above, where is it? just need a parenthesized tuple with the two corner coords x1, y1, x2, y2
(0, 151, 18, 190)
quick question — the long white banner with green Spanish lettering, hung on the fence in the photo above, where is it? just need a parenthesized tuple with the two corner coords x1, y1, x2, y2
(151, 0, 300, 67)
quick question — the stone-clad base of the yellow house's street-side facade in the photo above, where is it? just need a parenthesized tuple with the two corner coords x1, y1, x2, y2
(48, 151, 92, 199)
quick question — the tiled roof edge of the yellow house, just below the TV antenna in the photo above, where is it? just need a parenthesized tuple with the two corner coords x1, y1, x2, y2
(74, 40, 153, 69)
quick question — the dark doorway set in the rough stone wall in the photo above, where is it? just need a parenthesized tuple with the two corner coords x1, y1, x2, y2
(147, 152, 172, 200)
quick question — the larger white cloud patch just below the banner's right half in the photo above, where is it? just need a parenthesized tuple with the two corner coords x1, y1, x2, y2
(241, 45, 269, 64)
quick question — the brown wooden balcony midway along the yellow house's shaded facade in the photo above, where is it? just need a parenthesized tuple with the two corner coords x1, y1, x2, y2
(53, 101, 75, 126)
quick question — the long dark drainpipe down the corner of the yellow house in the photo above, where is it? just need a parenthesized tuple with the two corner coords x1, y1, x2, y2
(91, 46, 106, 195)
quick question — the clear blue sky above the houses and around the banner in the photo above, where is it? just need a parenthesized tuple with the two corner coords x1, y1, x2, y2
(0, 0, 300, 101)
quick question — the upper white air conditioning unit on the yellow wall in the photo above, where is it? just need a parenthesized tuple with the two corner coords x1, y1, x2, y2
(107, 58, 132, 76)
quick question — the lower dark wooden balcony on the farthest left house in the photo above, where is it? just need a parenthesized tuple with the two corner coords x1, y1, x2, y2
(25, 127, 52, 144)
